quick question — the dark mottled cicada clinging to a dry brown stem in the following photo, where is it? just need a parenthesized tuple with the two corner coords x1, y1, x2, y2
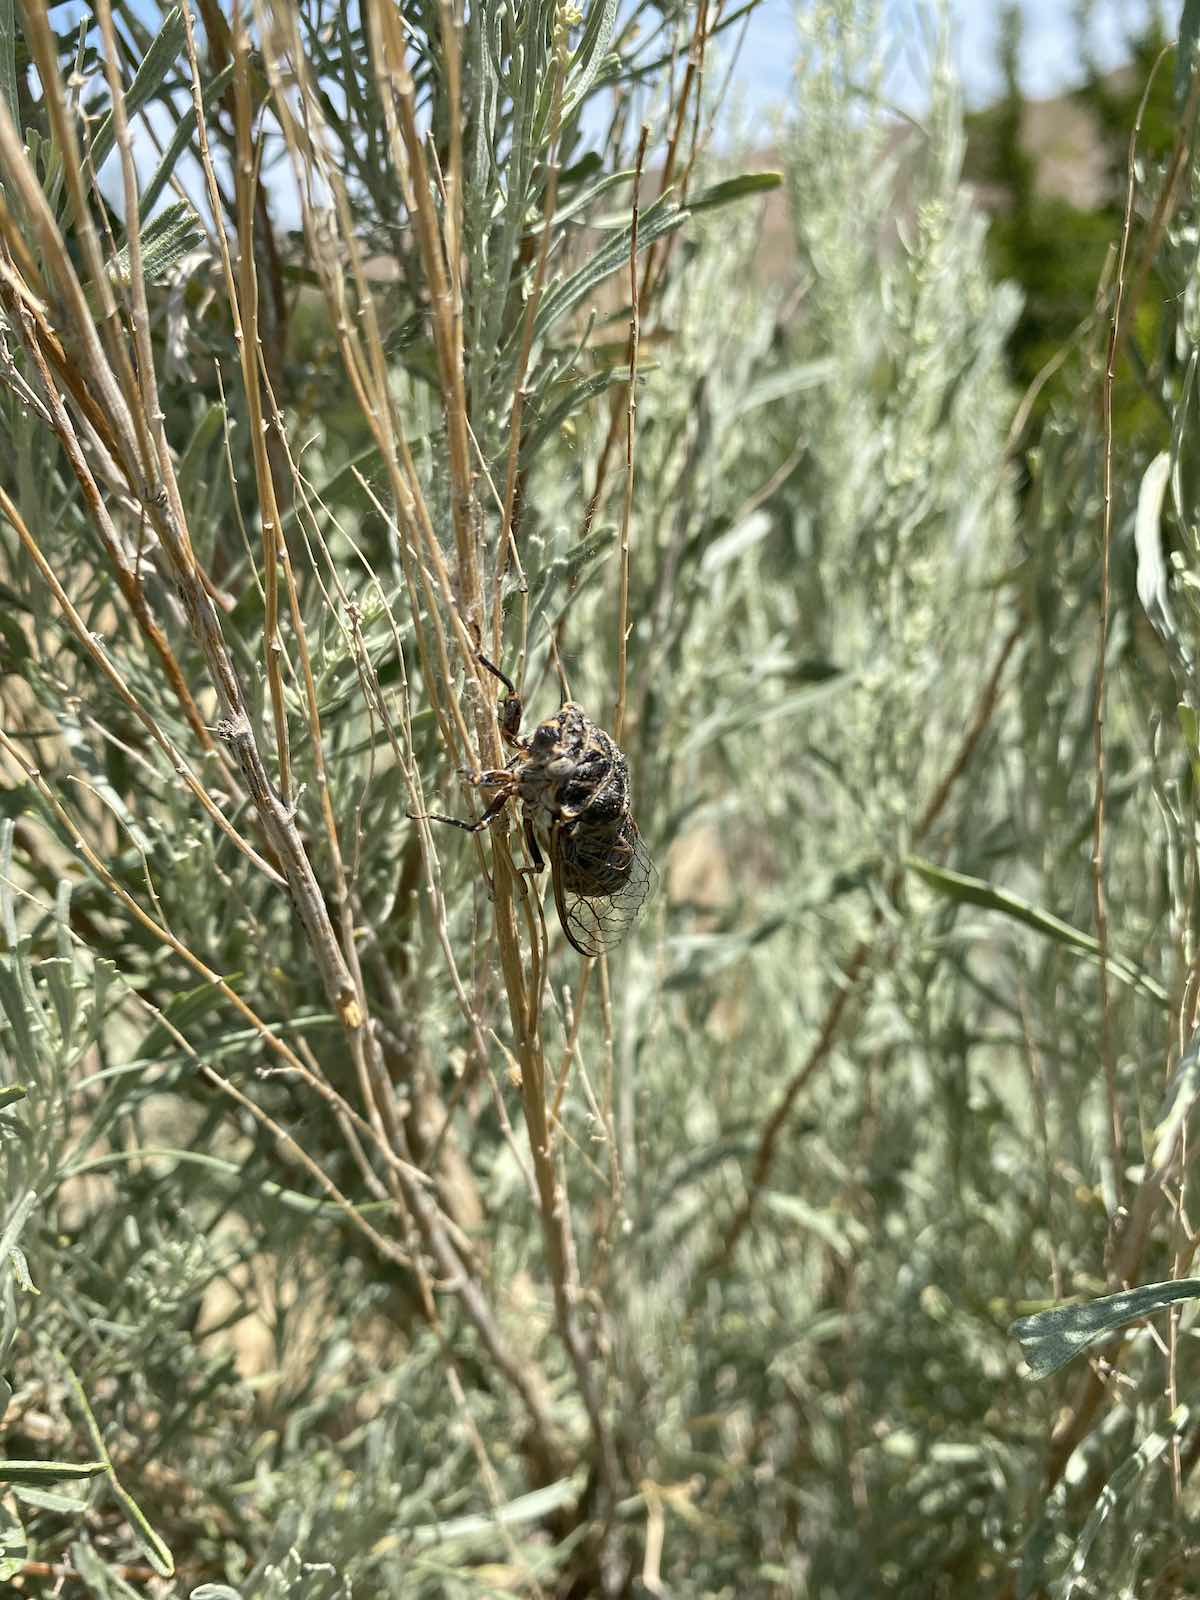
(412, 656, 658, 955)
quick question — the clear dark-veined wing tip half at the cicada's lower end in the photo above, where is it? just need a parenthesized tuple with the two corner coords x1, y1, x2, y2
(550, 818, 658, 957)
